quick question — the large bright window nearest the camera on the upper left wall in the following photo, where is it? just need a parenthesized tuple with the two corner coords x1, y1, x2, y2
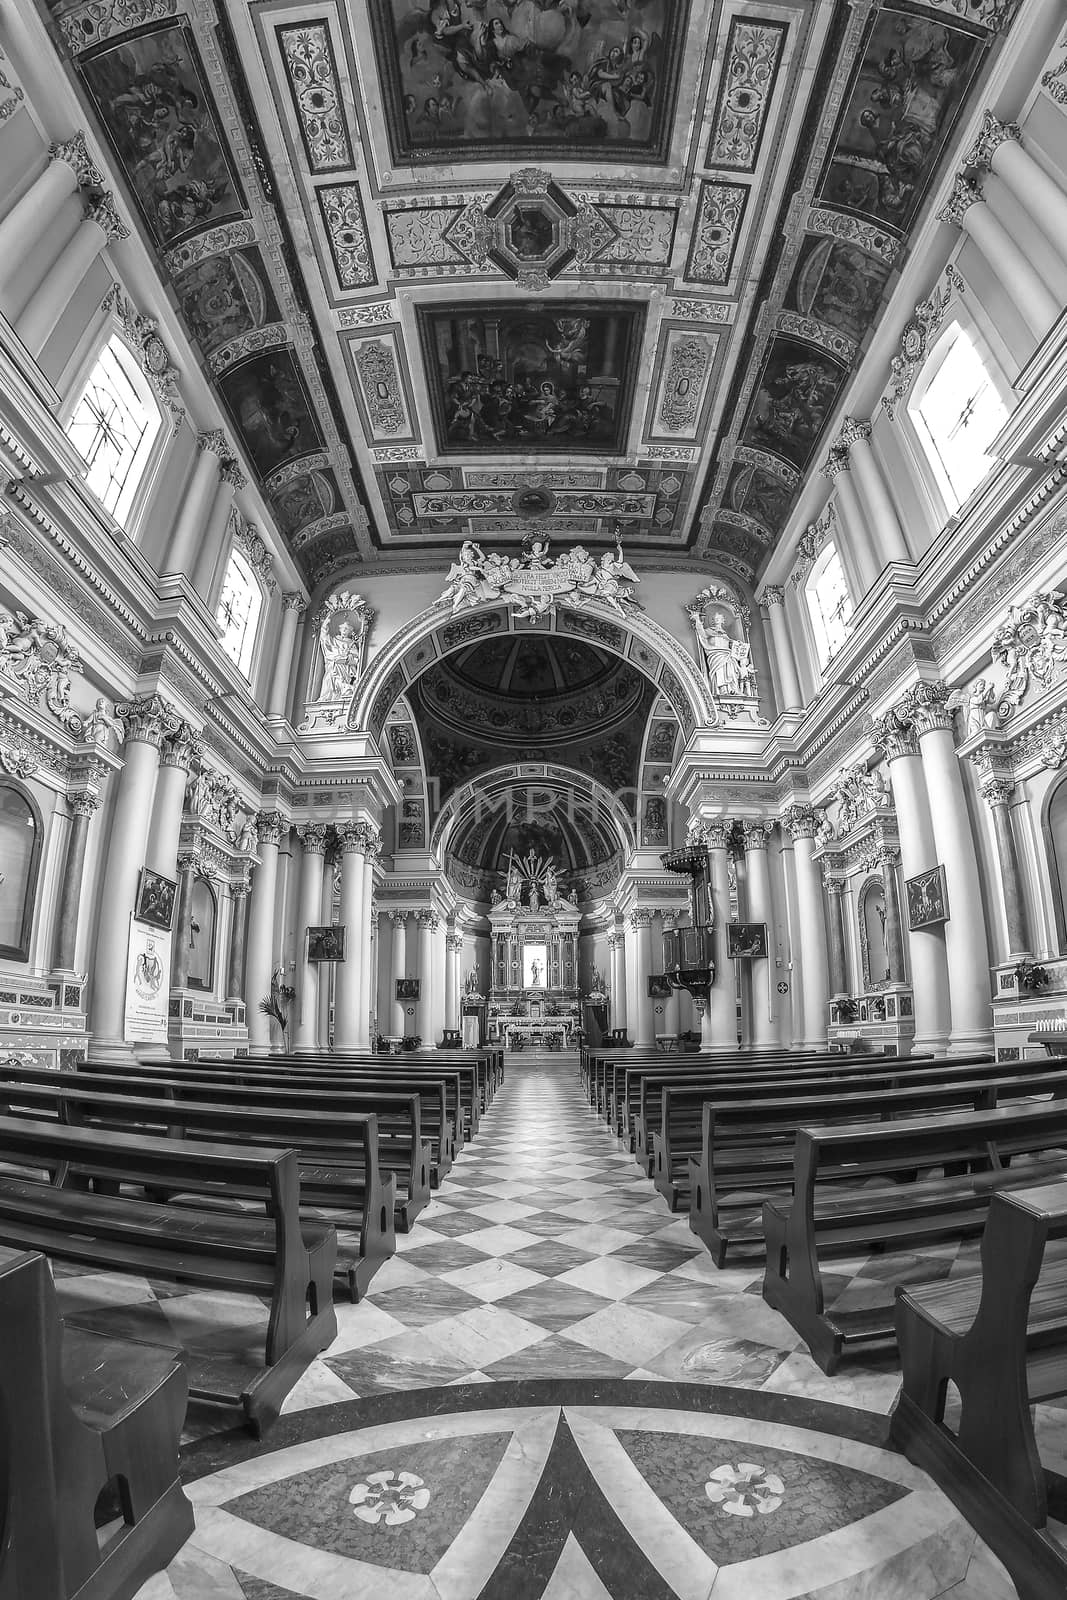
(67, 334, 163, 523)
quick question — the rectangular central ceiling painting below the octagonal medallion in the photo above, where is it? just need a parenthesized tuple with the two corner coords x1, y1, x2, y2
(419, 301, 645, 456)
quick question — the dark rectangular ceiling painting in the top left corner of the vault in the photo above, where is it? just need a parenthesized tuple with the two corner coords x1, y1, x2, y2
(78, 22, 245, 248)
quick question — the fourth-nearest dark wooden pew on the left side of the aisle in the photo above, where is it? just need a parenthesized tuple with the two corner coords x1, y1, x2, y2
(0, 1067, 430, 1235)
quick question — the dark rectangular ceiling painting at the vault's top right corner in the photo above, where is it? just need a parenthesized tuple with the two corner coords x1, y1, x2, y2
(821, 6, 989, 232)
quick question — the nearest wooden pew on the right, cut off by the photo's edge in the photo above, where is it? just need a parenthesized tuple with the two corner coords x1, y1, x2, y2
(889, 1182, 1067, 1600)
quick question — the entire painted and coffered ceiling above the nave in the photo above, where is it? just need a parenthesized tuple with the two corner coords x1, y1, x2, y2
(50, 0, 1014, 586)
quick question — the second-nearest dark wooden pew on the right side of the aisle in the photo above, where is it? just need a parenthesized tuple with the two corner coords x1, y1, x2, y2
(763, 1101, 1067, 1373)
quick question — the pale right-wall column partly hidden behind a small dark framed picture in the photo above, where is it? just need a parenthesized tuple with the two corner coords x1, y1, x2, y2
(875, 701, 952, 1054)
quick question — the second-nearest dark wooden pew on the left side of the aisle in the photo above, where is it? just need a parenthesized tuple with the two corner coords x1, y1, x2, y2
(0, 1117, 338, 1434)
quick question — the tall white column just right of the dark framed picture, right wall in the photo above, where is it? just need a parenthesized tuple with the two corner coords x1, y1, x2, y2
(907, 683, 993, 1054)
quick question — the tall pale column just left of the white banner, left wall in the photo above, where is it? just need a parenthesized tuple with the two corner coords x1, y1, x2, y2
(90, 694, 178, 1061)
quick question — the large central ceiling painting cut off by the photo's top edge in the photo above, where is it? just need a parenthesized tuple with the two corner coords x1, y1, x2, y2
(371, 0, 689, 165)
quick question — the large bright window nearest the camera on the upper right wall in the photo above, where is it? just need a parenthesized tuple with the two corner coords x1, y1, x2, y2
(907, 323, 1008, 510)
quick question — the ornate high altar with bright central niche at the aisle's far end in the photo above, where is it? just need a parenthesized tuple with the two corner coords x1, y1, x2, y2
(490, 858, 581, 1050)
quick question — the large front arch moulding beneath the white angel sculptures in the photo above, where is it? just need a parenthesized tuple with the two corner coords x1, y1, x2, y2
(349, 602, 715, 739)
